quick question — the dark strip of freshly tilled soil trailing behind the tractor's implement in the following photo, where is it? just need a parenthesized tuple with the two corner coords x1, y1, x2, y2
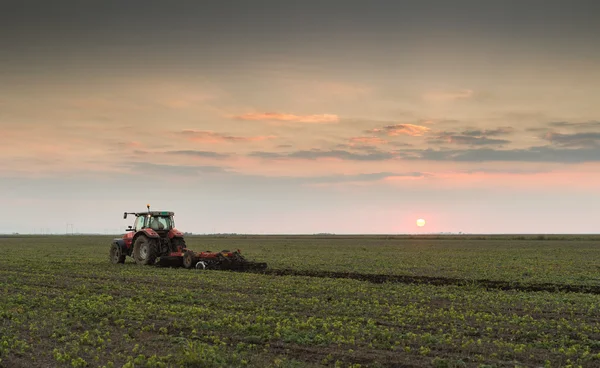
(253, 268, 600, 295)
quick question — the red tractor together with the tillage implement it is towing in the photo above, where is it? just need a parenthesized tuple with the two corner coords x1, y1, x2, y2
(110, 205, 267, 271)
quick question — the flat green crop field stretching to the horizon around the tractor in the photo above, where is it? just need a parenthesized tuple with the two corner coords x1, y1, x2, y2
(0, 236, 600, 367)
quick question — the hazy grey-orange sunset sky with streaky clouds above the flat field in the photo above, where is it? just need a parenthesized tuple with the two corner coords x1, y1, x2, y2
(0, 0, 600, 234)
